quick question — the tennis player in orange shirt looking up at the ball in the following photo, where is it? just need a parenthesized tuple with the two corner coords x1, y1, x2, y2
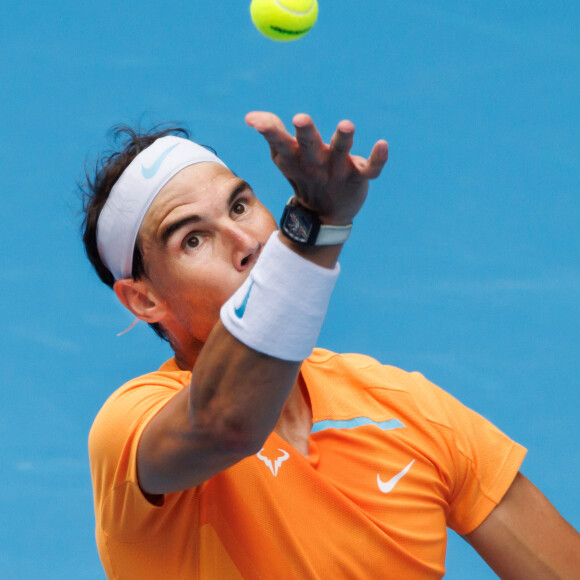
(84, 112, 580, 580)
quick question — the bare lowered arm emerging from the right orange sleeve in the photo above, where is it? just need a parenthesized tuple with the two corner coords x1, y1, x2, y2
(466, 473, 580, 580)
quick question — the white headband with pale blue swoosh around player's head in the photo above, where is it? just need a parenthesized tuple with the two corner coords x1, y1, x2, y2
(97, 135, 226, 280)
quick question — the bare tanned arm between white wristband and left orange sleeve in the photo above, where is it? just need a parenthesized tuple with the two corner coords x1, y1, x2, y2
(138, 322, 300, 495)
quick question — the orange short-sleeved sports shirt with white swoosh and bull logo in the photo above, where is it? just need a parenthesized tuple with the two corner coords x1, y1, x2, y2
(89, 349, 525, 580)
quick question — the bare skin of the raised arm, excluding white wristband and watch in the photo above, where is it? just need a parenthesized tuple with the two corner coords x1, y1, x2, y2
(137, 112, 388, 495)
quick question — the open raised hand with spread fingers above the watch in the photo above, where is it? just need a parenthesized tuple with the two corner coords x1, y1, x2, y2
(246, 111, 388, 225)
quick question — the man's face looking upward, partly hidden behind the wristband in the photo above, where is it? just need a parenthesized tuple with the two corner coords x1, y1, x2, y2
(139, 162, 277, 345)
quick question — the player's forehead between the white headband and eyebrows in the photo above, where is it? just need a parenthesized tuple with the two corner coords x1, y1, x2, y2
(139, 162, 241, 239)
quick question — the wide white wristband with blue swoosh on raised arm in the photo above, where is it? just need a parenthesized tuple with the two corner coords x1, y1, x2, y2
(220, 231, 340, 361)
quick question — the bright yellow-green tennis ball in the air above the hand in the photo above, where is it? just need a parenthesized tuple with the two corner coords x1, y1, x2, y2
(250, 0, 318, 42)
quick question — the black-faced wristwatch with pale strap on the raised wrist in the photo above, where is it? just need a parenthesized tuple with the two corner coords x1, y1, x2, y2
(280, 196, 352, 246)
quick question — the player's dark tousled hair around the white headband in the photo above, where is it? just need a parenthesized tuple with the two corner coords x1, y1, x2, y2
(79, 124, 190, 341)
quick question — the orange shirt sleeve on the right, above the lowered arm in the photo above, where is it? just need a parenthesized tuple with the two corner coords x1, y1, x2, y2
(413, 373, 526, 535)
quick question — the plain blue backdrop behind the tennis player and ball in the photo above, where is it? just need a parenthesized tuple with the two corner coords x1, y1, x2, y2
(0, 0, 580, 580)
